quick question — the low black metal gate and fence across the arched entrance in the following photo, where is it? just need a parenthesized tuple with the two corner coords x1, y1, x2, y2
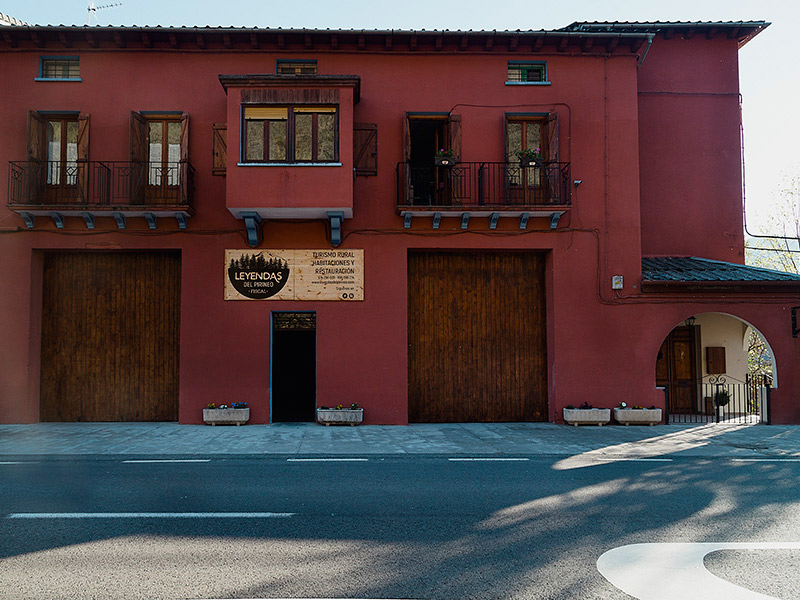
(666, 375, 772, 424)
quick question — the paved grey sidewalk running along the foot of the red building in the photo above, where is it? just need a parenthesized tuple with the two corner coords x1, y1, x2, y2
(0, 423, 800, 459)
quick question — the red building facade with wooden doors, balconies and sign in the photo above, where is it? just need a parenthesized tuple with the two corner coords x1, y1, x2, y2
(0, 22, 800, 424)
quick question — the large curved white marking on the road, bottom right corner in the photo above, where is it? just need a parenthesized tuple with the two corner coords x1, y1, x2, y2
(597, 542, 800, 600)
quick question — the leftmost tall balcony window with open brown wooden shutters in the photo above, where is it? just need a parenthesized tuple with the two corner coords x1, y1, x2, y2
(28, 111, 89, 204)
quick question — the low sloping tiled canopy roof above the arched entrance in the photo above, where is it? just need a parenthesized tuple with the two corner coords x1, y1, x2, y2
(642, 256, 800, 283)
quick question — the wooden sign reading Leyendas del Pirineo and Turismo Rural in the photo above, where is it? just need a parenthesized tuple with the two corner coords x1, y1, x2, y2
(225, 250, 364, 300)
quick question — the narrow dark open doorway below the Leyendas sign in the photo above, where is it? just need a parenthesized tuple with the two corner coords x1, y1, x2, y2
(271, 312, 317, 423)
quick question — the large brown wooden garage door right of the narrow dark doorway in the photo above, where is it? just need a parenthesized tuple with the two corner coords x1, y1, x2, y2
(408, 252, 547, 422)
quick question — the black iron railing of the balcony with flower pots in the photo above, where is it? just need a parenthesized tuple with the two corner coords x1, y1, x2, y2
(397, 162, 572, 210)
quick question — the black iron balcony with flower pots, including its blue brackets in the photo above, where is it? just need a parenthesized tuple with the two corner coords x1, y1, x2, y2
(397, 162, 572, 229)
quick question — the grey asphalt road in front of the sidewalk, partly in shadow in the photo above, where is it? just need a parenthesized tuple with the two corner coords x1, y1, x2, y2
(0, 456, 800, 600)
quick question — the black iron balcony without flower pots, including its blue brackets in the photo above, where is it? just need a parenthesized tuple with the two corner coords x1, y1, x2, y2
(8, 161, 194, 229)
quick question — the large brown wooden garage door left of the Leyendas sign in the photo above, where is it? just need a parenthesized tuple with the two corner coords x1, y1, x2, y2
(40, 252, 180, 421)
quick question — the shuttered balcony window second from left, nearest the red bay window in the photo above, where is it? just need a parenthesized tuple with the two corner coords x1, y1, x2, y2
(131, 111, 189, 204)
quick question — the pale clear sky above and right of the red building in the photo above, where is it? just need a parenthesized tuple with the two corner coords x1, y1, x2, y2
(6, 0, 800, 231)
